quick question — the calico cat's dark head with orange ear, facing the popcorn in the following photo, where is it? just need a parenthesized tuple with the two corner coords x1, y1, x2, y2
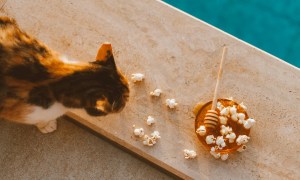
(83, 43, 129, 116)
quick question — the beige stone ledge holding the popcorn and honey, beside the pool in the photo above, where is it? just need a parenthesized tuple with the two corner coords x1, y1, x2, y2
(1, 0, 300, 179)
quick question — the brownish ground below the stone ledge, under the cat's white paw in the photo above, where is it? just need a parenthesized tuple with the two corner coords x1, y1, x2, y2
(0, 119, 171, 180)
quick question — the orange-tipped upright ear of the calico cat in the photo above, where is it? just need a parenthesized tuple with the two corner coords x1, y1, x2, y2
(96, 42, 116, 68)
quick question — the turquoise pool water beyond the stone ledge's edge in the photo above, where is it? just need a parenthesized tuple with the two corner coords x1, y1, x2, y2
(164, 0, 300, 67)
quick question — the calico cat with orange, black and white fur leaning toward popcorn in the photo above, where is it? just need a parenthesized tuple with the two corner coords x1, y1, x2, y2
(0, 17, 129, 133)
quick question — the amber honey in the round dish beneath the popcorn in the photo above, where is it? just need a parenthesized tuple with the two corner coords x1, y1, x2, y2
(195, 99, 250, 155)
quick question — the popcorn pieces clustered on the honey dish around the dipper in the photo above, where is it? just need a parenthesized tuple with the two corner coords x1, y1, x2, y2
(196, 102, 255, 160)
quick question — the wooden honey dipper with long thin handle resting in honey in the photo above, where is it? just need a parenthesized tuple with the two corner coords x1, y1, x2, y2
(204, 46, 227, 129)
